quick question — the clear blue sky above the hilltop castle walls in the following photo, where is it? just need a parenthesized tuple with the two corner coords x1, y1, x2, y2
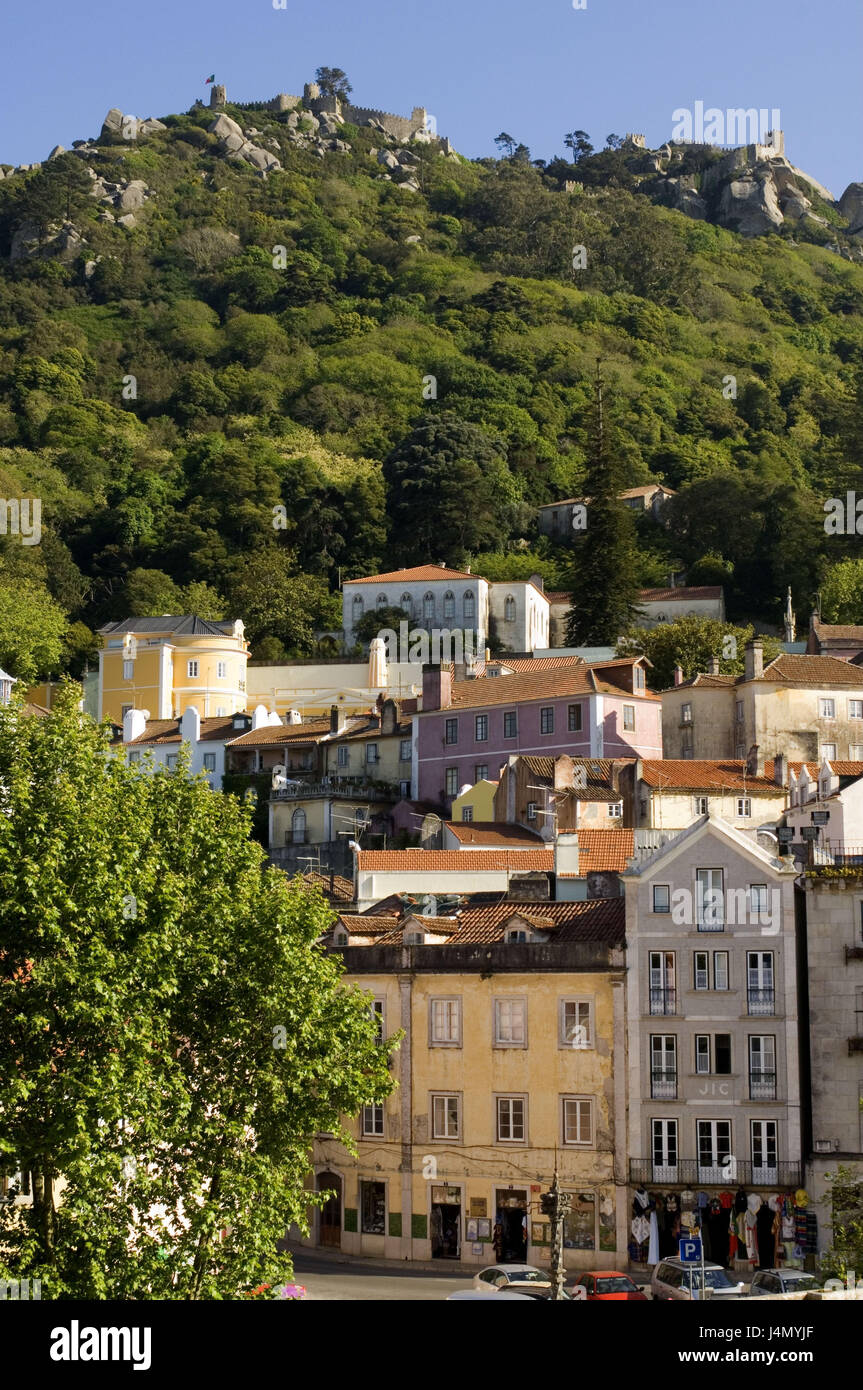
(0, 0, 863, 197)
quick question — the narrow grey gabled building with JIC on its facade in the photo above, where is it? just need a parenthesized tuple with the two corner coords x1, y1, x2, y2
(623, 816, 803, 1264)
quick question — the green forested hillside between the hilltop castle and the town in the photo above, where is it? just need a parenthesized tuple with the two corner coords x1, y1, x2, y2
(0, 96, 863, 676)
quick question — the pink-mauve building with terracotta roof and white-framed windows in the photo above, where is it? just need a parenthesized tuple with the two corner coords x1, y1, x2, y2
(413, 656, 663, 808)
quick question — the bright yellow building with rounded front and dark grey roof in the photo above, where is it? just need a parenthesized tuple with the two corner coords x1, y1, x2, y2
(99, 614, 249, 724)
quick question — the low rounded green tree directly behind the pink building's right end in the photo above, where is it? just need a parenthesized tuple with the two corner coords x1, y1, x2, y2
(617, 617, 782, 691)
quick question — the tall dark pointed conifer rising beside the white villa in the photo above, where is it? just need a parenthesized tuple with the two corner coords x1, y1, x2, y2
(564, 363, 638, 646)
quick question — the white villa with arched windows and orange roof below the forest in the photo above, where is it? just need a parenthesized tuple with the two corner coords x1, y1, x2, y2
(342, 564, 550, 660)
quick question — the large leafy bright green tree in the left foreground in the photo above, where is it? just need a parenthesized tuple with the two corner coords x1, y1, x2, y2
(0, 684, 392, 1300)
